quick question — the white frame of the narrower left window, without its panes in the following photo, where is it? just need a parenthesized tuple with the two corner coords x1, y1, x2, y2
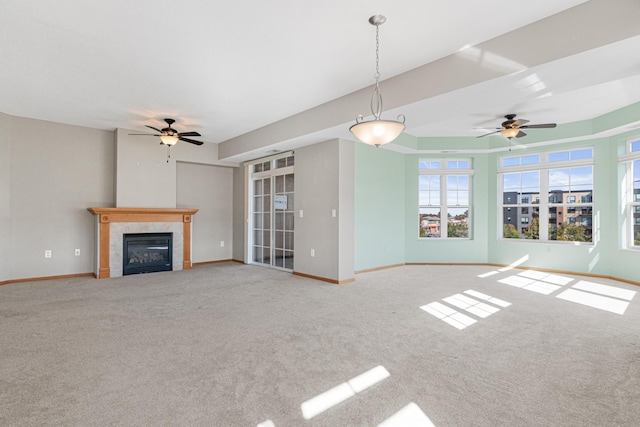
(418, 157, 475, 241)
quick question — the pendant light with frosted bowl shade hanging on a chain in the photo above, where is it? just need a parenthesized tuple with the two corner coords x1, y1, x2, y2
(349, 15, 405, 147)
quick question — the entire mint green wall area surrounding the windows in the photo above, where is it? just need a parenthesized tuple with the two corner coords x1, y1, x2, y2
(355, 103, 640, 281)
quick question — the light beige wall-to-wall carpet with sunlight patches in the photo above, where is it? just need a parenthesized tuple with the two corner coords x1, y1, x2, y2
(0, 263, 640, 427)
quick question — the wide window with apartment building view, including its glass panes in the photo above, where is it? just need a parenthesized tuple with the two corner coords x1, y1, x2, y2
(499, 148, 593, 242)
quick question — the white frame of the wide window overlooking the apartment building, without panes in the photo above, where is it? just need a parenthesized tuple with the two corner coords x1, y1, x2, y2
(497, 146, 596, 245)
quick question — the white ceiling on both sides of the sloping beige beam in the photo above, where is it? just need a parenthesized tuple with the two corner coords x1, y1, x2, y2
(0, 0, 640, 160)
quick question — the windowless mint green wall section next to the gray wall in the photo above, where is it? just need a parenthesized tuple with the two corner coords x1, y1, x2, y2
(354, 143, 406, 271)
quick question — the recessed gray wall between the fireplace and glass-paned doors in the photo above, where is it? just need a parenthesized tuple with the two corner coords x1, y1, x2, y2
(176, 162, 237, 263)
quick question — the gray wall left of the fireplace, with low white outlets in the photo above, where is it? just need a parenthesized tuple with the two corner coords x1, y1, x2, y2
(0, 115, 115, 281)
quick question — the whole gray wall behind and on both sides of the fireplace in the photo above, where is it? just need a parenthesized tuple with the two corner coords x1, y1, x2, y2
(0, 113, 242, 282)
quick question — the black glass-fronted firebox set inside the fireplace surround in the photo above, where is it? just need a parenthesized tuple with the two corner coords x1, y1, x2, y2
(122, 233, 173, 276)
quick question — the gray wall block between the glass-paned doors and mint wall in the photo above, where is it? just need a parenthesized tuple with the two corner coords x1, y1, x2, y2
(294, 140, 354, 281)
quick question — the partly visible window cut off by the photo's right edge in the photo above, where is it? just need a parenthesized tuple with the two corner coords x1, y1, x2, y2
(620, 140, 640, 249)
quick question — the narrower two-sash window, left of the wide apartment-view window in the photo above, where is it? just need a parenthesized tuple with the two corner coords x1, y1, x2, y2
(418, 159, 473, 239)
